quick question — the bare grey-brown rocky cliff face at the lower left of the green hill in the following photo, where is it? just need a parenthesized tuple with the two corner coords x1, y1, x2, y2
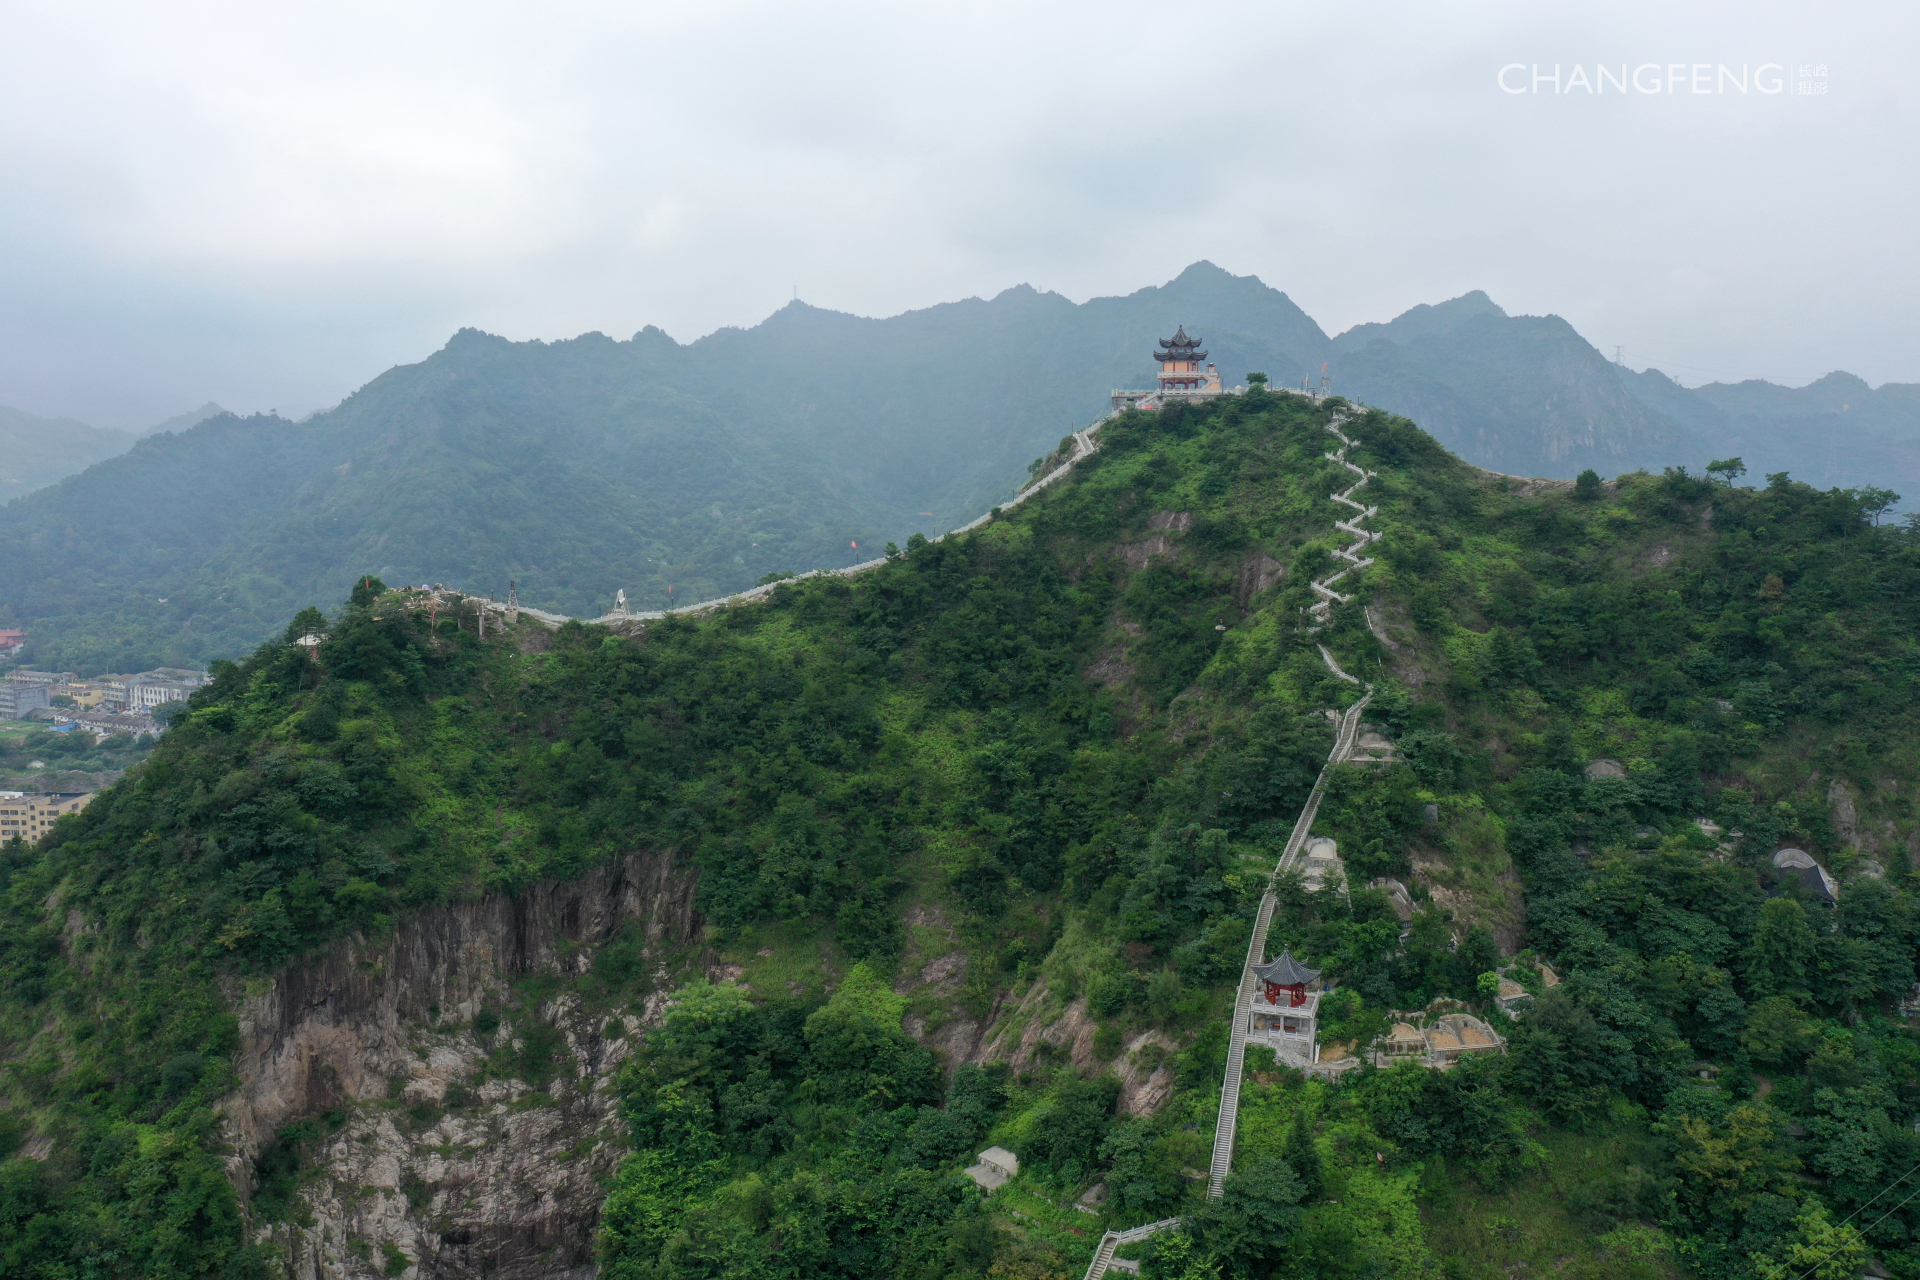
(227, 854, 701, 1280)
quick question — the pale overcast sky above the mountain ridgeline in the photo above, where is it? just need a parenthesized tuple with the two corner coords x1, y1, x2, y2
(0, 0, 1920, 426)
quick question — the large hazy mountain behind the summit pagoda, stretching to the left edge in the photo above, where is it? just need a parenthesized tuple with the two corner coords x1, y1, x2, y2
(0, 265, 1323, 670)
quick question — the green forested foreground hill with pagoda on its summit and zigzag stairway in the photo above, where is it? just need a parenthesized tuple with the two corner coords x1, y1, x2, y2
(0, 391, 1920, 1280)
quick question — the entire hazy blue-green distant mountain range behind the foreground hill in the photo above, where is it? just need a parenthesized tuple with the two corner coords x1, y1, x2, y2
(0, 263, 1920, 670)
